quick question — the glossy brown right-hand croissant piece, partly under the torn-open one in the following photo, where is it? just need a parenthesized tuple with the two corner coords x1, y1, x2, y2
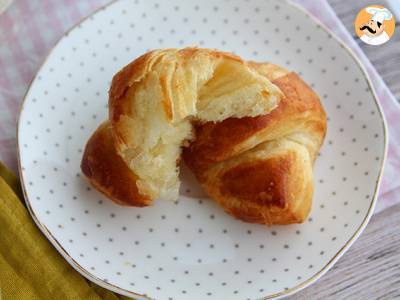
(183, 64, 326, 224)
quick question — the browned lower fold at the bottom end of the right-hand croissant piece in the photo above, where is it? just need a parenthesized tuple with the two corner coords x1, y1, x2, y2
(202, 141, 313, 225)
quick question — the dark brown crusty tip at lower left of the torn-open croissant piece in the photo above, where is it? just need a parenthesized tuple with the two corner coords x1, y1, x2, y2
(81, 122, 151, 207)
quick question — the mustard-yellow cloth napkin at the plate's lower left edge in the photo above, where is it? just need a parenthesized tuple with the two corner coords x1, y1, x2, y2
(0, 162, 133, 300)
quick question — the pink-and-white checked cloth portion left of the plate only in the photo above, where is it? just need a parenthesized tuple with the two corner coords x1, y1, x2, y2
(0, 0, 109, 171)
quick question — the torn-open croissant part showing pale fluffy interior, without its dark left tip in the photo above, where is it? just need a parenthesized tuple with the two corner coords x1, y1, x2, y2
(109, 48, 282, 200)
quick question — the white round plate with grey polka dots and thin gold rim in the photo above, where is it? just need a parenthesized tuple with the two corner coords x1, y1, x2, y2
(18, 0, 387, 299)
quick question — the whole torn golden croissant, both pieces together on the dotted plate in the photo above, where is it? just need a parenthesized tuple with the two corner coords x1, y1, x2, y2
(81, 48, 326, 224)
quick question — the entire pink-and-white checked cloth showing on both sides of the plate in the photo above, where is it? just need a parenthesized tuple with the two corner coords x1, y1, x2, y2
(0, 0, 400, 211)
